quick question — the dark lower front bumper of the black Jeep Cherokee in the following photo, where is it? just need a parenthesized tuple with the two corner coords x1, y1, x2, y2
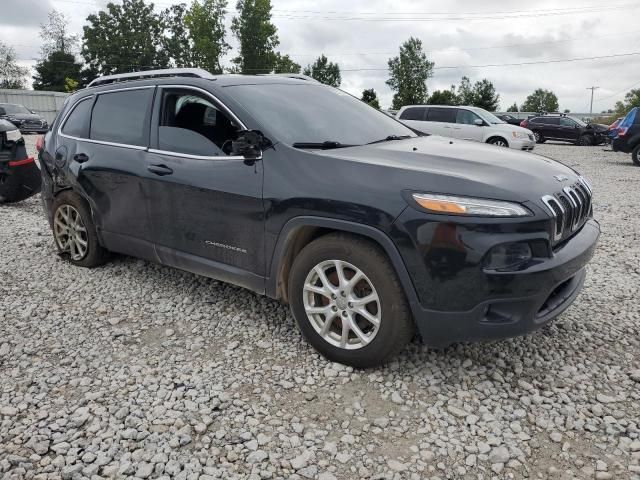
(396, 219, 600, 347)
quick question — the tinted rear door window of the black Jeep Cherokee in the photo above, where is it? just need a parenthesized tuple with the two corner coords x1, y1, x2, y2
(90, 87, 153, 147)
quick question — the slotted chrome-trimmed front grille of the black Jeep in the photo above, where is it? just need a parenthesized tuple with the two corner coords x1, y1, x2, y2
(542, 182, 592, 243)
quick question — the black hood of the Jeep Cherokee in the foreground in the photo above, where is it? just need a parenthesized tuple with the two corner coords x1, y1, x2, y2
(316, 135, 579, 205)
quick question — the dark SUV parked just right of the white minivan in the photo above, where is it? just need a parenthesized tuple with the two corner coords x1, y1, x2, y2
(520, 114, 608, 146)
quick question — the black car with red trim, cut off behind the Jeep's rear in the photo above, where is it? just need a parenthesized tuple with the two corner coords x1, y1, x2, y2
(0, 120, 42, 203)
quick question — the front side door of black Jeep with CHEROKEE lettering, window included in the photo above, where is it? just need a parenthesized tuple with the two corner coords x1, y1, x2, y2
(145, 87, 265, 290)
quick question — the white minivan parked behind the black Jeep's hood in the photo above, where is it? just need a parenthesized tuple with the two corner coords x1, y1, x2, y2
(396, 105, 536, 150)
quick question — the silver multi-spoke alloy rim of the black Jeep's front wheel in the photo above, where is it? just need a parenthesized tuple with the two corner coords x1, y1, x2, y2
(303, 260, 382, 350)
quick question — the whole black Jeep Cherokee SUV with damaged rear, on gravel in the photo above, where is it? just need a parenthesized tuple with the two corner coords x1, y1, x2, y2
(40, 69, 600, 367)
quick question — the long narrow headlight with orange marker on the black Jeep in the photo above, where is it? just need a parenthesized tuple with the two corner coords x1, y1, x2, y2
(413, 193, 531, 217)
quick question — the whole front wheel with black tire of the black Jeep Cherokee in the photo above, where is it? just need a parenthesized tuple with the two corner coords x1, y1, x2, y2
(288, 233, 414, 368)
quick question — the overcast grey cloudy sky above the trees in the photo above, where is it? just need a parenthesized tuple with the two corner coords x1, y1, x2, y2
(0, 0, 640, 112)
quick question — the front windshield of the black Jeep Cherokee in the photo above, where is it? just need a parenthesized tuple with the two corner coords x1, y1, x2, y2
(227, 83, 416, 146)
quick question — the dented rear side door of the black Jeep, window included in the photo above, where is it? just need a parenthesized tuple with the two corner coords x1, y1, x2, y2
(61, 86, 155, 259)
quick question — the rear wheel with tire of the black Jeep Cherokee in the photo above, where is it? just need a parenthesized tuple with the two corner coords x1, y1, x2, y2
(51, 191, 108, 268)
